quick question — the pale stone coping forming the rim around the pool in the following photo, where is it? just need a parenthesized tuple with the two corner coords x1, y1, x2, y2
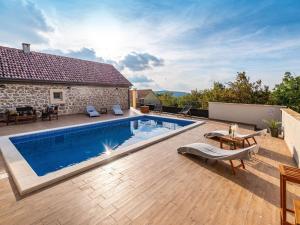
(0, 114, 205, 195)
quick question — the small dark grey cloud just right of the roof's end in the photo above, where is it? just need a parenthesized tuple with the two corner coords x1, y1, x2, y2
(119, 52, 164, 71)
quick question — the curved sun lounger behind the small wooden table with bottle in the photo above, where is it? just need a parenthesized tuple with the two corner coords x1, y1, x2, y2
(204, 129, 267, 145)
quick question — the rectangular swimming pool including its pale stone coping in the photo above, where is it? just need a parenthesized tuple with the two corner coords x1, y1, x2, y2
(0, 115, 202, 194)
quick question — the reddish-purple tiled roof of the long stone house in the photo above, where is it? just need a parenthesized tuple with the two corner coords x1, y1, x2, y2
(0, 46, 132, 87)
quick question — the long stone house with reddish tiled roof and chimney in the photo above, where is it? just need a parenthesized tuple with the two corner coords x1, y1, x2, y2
(0, 44, 132, 114)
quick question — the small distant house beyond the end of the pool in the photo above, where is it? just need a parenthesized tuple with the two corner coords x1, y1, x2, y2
(130, 89, 161, 107)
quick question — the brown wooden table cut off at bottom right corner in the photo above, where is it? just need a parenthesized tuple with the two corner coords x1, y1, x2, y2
(279, 165, 300, 225)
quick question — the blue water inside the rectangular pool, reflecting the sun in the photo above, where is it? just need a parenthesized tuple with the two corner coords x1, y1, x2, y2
(10, 116, 193, 176)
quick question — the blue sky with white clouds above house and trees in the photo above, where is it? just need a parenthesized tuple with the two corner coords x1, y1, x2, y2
(0, 0, 300, 92)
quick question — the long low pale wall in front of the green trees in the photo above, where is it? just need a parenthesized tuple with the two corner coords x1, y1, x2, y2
(208, 102, 285, 129)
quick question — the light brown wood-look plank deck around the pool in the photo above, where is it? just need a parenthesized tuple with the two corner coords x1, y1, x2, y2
(0, 115, 300, 225)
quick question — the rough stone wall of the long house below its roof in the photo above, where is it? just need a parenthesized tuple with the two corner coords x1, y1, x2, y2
(0, 83, 128, 114)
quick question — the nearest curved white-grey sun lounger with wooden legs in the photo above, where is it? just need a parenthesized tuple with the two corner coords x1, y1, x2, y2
(177, 143, 259, 174)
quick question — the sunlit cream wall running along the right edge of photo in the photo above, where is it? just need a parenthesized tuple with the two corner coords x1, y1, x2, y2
(282, 109, 300, 167)
